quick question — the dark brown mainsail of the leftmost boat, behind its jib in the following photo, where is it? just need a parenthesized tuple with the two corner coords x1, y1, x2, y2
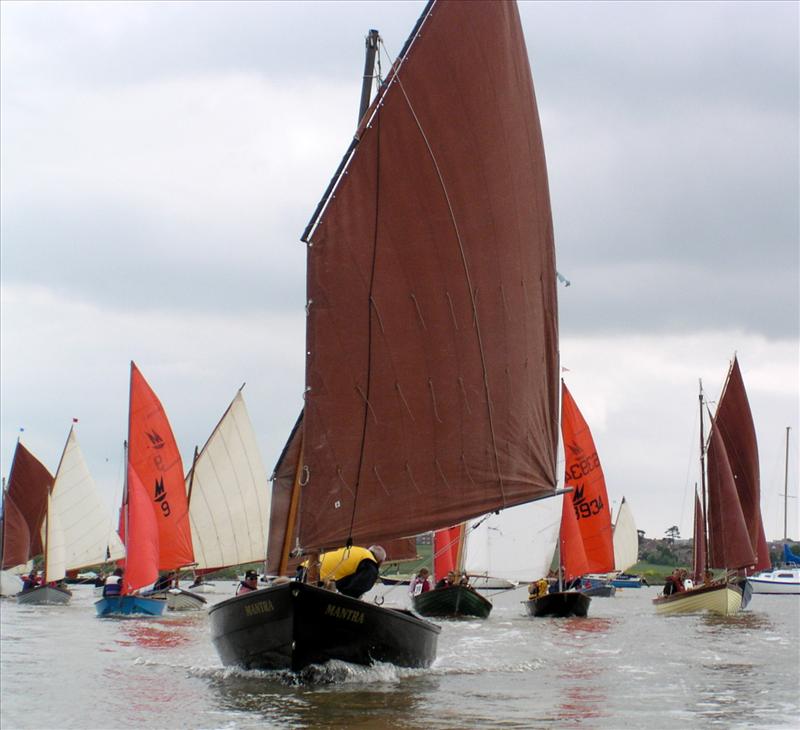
(3, 441, 53, 563)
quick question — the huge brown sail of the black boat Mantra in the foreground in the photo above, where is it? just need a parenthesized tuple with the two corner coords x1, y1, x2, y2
(300, 0, 558, 548)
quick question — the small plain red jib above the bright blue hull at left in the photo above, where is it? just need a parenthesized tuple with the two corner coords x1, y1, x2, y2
(123, 464, 159, 593)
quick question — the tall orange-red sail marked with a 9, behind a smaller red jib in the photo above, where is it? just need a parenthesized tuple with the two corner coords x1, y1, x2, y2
(128, 363, 194, 570)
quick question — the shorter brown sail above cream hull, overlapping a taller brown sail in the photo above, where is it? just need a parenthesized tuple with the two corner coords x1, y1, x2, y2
(706, 421, 757, 570)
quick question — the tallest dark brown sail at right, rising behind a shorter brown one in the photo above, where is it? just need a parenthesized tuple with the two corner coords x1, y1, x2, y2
(714, 356, 771, 570)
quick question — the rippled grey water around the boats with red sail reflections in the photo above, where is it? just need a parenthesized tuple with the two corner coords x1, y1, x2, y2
(0, 583, 800, 730)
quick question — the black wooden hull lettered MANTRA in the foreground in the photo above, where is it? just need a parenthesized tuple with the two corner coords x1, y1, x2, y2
(209, 582, 441, 671)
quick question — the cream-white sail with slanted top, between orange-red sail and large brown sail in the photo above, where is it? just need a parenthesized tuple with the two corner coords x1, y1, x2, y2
(186, 391, 271, 569)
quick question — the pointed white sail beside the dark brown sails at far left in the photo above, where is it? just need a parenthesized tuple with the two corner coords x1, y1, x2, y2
(42, 428, 125, 582)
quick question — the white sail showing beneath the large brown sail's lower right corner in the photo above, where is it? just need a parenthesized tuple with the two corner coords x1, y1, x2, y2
(464, 499, 561, 583)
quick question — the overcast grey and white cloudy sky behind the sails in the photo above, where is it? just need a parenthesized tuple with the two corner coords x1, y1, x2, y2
(0, 0, 800, 539)
